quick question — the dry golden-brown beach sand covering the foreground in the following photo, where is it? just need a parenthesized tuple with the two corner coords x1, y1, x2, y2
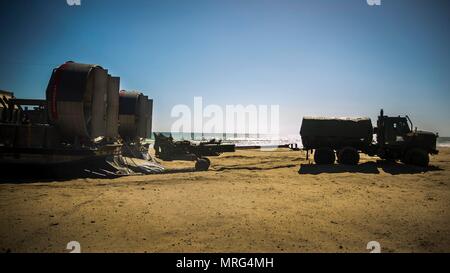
(0, 149, 450, 252)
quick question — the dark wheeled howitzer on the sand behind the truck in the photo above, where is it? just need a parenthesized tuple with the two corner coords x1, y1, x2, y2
(154, 133, 236, 171)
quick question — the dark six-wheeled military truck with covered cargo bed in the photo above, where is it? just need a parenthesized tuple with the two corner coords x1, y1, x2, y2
(300, 110, 438, 166)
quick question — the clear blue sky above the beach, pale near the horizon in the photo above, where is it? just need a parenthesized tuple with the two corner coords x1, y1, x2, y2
(0, 0, 450, 136)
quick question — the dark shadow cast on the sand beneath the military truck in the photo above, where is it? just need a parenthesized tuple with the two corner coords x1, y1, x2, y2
(298, 160, 443, 175)
